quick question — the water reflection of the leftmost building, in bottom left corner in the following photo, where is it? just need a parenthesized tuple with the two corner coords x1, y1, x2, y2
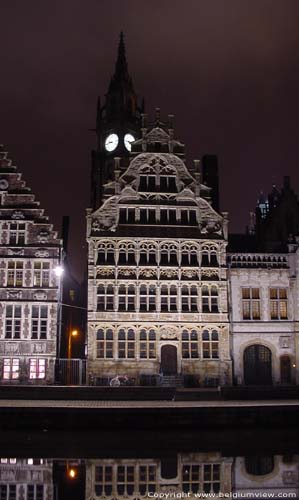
(0, 458, 54, 500)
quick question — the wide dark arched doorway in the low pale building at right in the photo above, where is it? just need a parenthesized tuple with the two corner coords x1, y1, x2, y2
(244, 344, 272, 385)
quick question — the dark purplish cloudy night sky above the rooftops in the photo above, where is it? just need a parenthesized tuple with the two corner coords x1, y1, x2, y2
(0, 0, 299, 275)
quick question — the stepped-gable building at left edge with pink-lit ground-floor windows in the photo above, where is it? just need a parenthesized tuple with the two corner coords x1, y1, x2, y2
(0, 146, 62, 384)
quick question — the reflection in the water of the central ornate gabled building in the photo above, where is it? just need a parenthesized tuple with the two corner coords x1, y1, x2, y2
(86, 453, 232, 500)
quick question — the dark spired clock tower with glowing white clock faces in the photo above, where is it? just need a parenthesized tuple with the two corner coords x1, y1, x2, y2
(91, 33, 144, 210)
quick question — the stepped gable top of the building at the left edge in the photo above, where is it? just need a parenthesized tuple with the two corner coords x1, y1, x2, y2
(0, 144, 61, 246)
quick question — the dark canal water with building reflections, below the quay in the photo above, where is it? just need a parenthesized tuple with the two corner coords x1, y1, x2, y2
(0, 422, 299, 500)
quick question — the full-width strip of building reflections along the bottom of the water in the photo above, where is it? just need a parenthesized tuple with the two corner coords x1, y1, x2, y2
(0, 452, 299, 500)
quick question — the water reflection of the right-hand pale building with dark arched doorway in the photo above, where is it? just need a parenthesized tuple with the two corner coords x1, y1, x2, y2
(233, 455, 299, 498)
